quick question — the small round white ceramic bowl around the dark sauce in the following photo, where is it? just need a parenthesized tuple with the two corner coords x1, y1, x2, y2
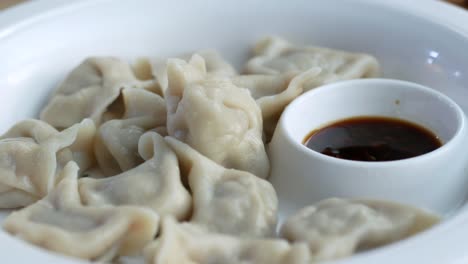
(269, 79, 468, 219)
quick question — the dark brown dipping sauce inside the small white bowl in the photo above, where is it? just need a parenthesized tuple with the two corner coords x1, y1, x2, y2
(304, 117, 442, 161)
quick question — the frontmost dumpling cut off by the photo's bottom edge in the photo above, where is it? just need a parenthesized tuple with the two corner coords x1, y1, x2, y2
(144, 218, 310, 264)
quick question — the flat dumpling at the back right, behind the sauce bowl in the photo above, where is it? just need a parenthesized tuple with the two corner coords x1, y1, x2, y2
(245, 37, 379, 91)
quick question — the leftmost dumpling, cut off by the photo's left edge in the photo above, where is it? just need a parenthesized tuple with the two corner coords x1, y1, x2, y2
(0, 119, 96, 208)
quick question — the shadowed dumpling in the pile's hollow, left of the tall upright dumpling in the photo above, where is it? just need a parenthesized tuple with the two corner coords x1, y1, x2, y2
(94, 88, 166, 176)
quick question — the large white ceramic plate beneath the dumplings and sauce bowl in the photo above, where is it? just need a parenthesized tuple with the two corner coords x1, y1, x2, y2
(0, 0, 468, 264)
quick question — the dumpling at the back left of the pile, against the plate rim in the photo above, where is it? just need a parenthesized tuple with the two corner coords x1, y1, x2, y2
(40, 57, 154, 129)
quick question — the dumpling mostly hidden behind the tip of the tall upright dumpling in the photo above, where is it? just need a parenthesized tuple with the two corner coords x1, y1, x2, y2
(149, 50, 237, 93)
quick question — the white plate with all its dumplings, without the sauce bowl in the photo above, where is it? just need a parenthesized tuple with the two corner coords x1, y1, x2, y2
(0, 0, 468, 264)
